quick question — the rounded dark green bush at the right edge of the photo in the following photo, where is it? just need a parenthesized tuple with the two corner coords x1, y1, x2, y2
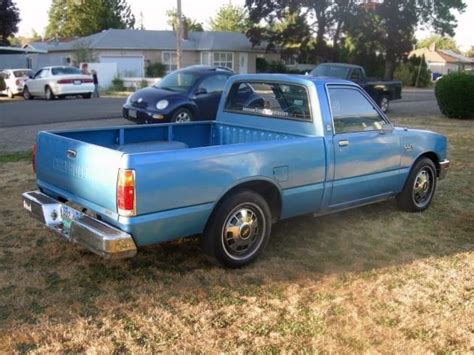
(435, 72, 474, 118)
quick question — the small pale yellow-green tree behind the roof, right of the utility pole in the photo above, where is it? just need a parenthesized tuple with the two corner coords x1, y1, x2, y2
(209, 4, 250, 33)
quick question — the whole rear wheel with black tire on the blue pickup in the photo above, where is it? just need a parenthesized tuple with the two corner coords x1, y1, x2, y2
(201, 190, 272, 268)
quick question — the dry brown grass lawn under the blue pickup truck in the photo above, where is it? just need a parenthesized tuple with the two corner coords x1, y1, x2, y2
(0, 117, 474, 353)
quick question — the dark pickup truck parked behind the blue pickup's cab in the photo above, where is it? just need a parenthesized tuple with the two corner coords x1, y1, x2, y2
(311, 63, 402, 112)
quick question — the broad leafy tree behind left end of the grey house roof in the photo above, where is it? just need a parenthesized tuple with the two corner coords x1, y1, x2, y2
(46, 0, 135, 38)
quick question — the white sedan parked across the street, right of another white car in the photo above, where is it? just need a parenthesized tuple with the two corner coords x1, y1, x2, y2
(23, 66, 94, 100)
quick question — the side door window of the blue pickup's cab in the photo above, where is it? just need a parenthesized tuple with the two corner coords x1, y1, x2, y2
(329, 87, 385, 134)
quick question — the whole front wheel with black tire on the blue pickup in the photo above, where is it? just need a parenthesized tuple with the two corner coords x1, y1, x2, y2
(397, 158, 437, 212)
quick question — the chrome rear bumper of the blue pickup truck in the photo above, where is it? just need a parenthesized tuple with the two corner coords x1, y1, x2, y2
(22, 191, 137, 259)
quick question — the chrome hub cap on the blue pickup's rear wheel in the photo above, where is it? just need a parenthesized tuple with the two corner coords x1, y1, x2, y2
(223, 207, 262, 255)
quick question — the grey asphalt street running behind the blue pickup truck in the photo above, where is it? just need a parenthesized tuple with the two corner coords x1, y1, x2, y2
(0, 89, 440, 152)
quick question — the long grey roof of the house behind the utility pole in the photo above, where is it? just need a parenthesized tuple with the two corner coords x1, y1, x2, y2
(30, 29, 265, 52)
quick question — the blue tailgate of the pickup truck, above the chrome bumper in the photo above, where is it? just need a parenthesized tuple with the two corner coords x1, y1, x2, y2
(36, 132, 123, 217)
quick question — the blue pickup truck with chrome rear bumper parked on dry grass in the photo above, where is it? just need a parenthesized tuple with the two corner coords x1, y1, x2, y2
(23, 74, 449, 267)
